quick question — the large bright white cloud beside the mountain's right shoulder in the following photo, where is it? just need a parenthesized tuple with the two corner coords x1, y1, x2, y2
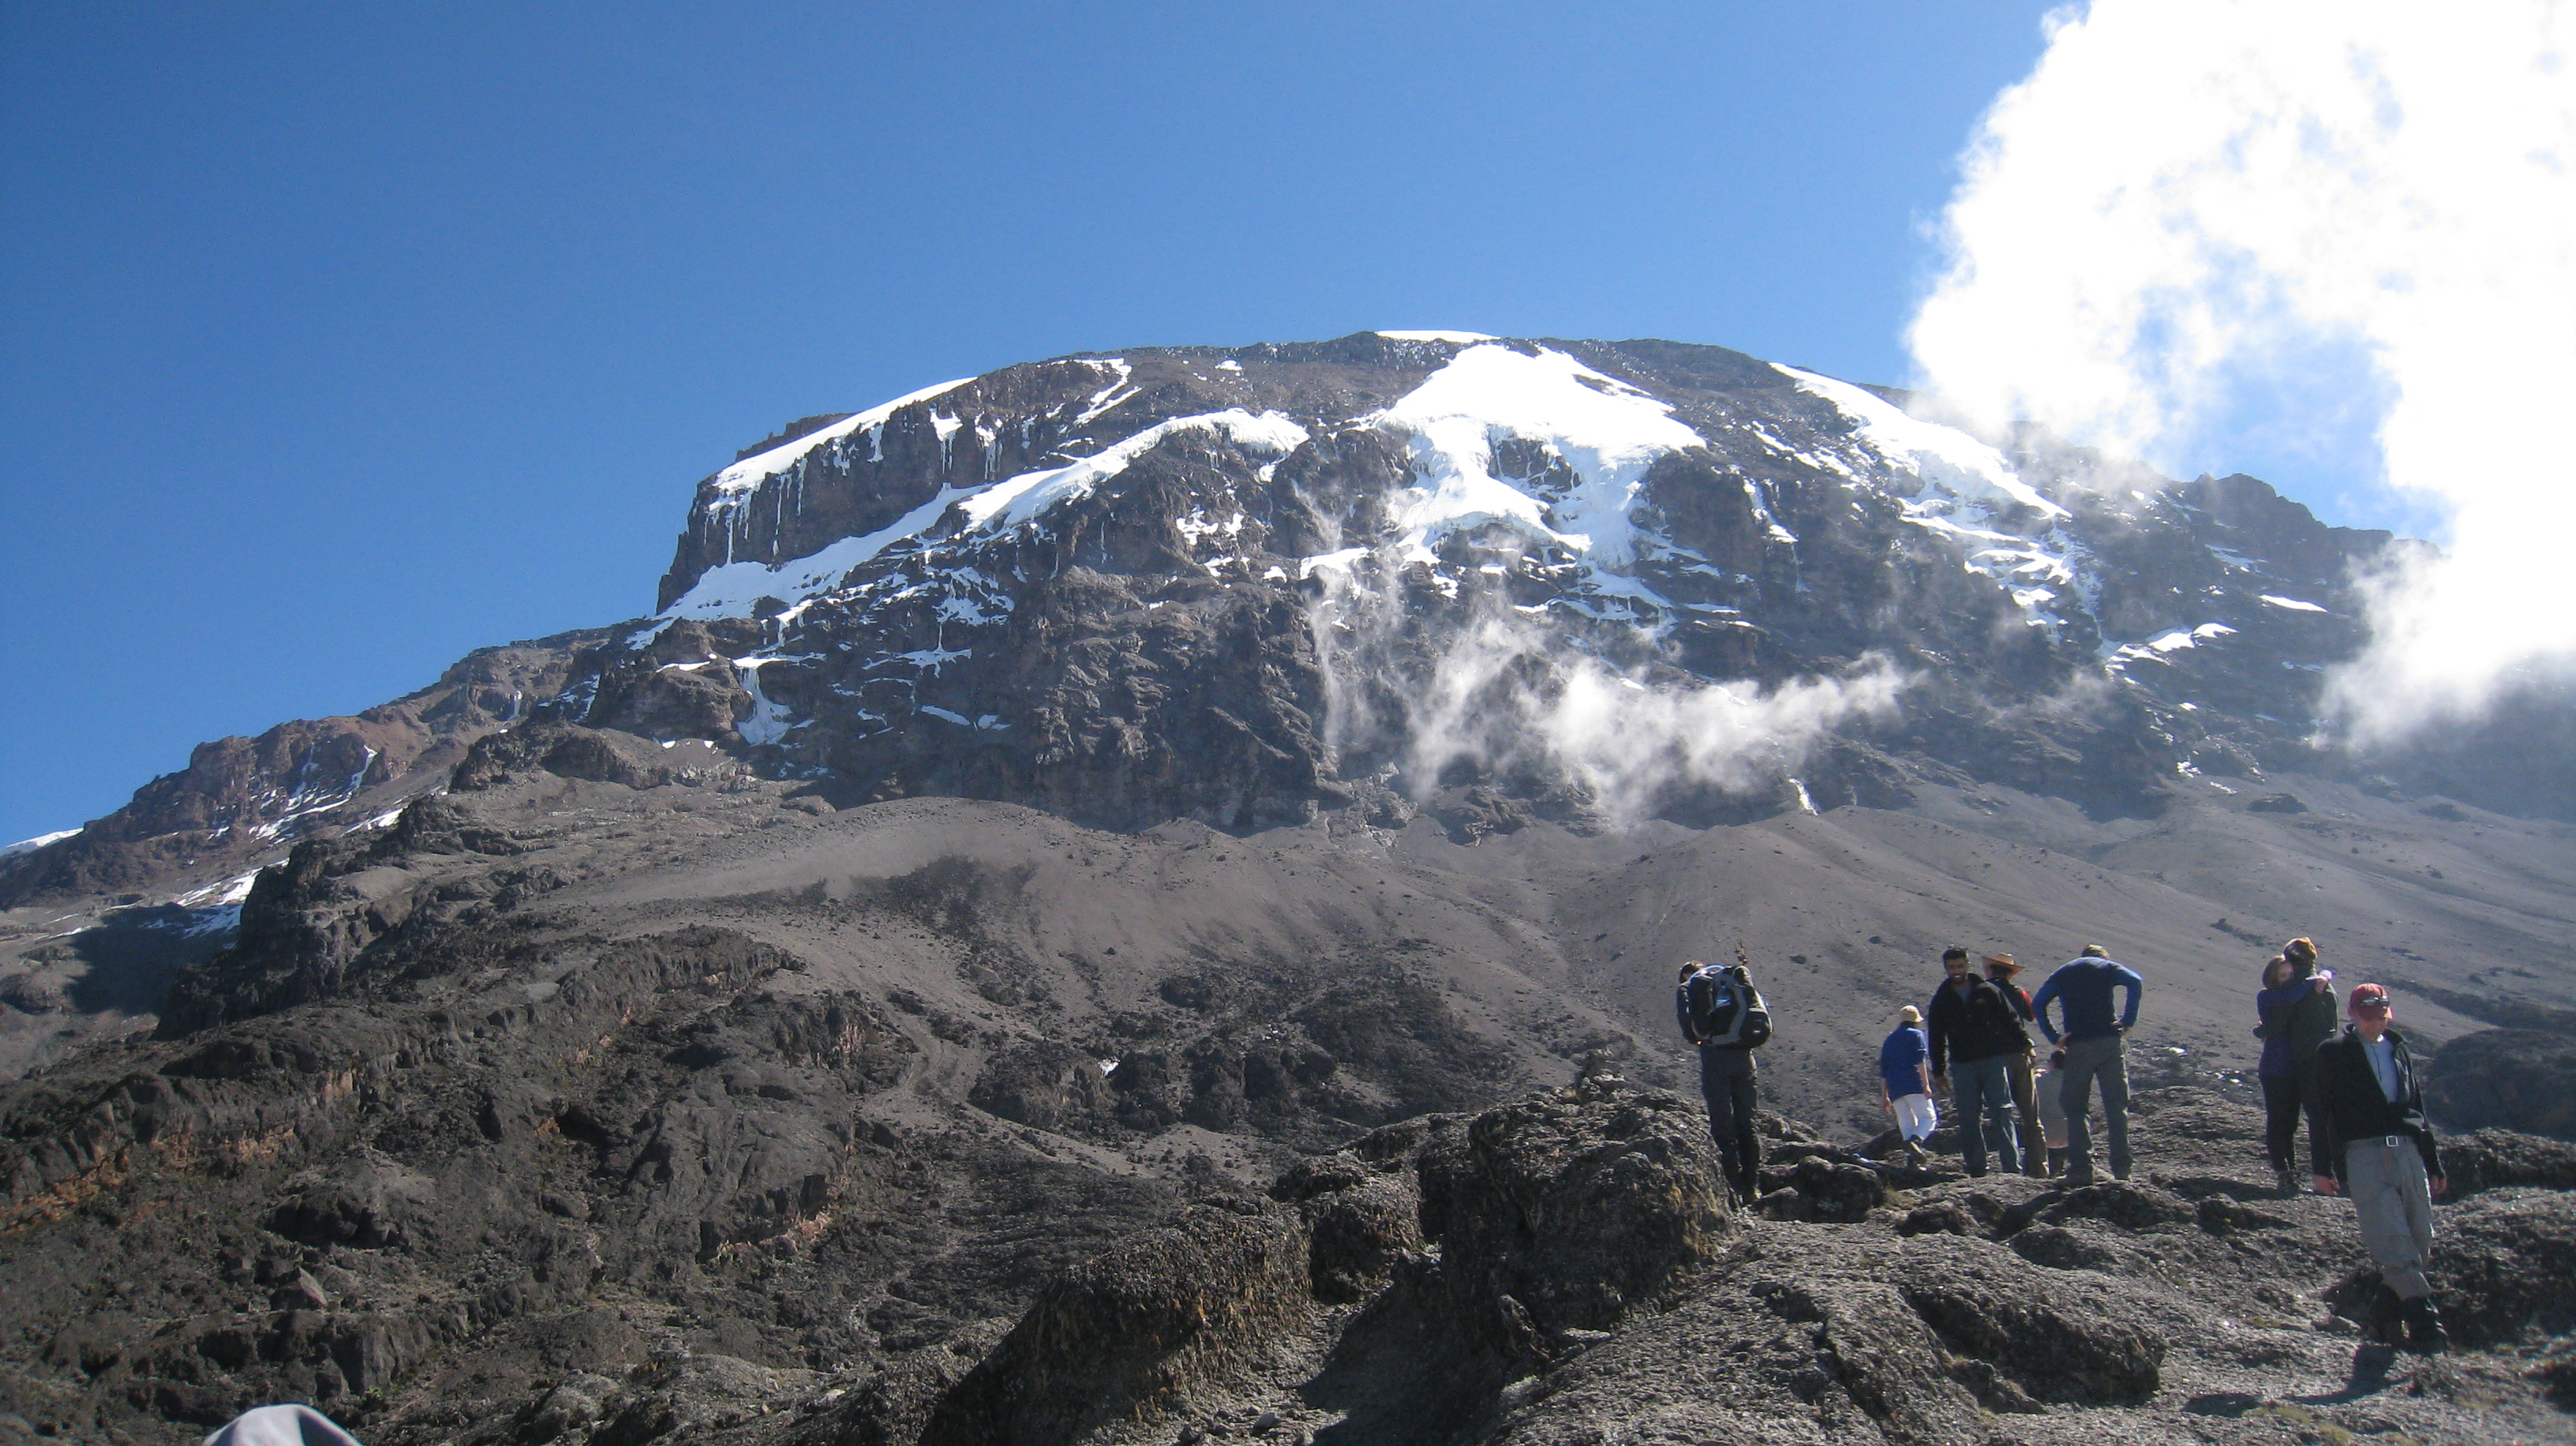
(1909, 0, 2576, 742)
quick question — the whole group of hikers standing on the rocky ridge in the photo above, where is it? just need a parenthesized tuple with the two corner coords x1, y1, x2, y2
(1675, 938, 2450, 1353)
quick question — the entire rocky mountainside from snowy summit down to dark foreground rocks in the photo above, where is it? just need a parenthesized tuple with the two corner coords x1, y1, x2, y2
(0, 332, 2576, 1446)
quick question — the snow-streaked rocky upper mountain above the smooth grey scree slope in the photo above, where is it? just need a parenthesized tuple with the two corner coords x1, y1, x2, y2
(0, 332, 2534, 905)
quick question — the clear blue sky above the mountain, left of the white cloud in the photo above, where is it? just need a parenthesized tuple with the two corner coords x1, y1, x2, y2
(0, 2, 2379, 841)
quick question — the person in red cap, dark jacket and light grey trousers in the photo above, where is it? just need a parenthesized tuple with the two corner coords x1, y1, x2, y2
(2316, 984, 2450, 1356)
